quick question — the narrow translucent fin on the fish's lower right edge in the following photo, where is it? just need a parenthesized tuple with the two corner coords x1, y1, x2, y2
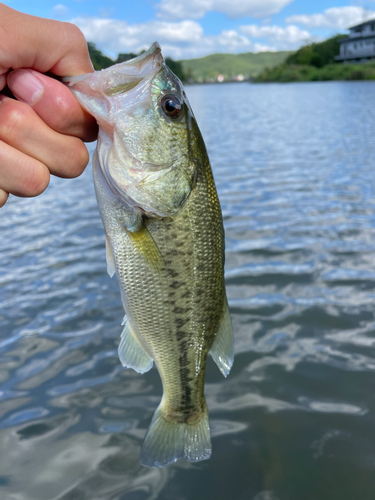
(210, 298, 234, 377)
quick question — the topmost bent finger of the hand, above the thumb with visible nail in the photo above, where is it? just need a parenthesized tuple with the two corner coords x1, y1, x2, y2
(0, 4, 93, 77)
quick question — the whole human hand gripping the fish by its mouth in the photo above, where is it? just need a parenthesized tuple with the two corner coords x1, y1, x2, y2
(0, 4, 97, 207)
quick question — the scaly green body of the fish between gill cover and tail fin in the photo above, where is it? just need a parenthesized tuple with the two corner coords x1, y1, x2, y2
(115, 160, 225, 422)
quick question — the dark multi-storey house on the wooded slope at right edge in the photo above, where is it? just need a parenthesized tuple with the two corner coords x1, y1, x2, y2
(335, 19, 375, 63)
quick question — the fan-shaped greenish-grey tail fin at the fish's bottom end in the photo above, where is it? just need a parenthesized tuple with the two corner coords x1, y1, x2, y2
(141, 405, 211, 467)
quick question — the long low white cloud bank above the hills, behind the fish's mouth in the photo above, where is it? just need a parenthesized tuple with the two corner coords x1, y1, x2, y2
(71, 17, 310, 59)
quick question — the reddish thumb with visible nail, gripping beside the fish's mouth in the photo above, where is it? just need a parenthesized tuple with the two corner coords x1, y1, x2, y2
(8, 69, 97, 142)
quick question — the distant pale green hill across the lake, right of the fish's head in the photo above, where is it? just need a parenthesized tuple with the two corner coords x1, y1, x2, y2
(180, 51, 291, 82)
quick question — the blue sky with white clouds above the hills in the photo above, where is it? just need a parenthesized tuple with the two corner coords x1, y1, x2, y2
(3, 0, 375, 59)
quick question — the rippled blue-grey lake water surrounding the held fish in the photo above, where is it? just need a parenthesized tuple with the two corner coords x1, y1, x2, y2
(0, 82, 375, 500)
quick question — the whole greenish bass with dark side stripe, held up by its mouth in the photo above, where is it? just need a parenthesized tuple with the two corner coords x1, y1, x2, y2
(65, 42, 234, 468)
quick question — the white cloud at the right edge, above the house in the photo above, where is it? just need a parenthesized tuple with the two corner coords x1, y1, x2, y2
(286, 6, 375, 30)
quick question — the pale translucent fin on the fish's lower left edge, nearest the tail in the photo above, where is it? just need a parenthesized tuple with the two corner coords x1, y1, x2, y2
(118, 317, 153, 373)
